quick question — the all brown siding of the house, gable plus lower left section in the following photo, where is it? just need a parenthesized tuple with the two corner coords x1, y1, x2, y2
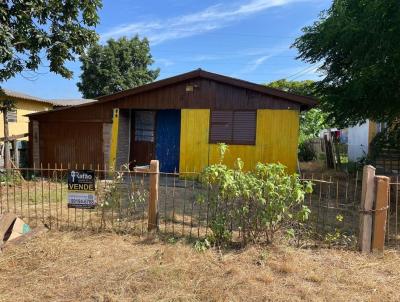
(30, 73, 301, 166)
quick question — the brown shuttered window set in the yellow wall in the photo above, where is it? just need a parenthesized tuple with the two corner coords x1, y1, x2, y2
(210, 110, 257, 145)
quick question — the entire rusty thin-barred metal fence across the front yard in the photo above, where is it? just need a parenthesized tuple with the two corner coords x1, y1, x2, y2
(0, 166, 362, 243)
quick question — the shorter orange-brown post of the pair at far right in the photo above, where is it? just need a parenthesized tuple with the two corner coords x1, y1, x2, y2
(372, 176, 390, 253)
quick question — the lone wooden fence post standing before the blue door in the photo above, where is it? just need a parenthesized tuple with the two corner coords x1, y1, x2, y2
(147, 160, 160, 232)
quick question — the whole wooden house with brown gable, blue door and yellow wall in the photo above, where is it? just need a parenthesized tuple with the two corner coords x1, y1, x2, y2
(29, 69, 316, 172)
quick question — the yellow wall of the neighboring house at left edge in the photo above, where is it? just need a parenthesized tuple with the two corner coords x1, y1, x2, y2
(0, 99, 53, 140)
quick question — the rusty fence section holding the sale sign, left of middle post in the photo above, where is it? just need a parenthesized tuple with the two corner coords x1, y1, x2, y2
(0, 165, 148, 234)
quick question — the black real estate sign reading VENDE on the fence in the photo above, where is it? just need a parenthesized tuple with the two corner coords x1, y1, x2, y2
(68, 170, 96, 209)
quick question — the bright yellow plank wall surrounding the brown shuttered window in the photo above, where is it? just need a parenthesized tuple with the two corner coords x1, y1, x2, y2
(179, 109, 299, 173)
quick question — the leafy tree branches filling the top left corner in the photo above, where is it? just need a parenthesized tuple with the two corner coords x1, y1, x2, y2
(0, 0, 101, 83)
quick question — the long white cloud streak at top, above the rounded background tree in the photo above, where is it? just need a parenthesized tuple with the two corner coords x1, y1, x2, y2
(101, 0, 313, 45)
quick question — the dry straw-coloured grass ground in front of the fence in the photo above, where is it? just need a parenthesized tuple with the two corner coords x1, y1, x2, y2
(0, 231, 400, 301)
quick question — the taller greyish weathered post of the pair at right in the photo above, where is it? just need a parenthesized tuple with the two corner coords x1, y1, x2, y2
(358, 166, 375, 253)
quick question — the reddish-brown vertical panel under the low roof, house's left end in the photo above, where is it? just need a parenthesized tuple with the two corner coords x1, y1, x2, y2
(39, 122, 104, 168)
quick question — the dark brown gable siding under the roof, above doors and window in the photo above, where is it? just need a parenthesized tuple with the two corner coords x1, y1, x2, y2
(31, 79, 300, 123)
